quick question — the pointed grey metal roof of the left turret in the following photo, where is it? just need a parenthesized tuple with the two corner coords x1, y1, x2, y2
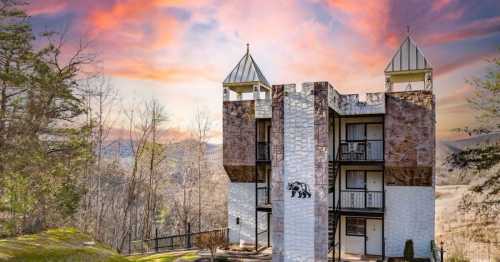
(223, 45, 270, 87)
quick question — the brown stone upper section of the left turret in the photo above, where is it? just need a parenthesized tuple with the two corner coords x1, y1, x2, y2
(223, 100, 255, 182)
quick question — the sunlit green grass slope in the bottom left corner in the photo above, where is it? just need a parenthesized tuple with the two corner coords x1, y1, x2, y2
(0, 228, 130, 262)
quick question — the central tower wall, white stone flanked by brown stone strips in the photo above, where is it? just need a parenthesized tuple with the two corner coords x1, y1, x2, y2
(272, 82, 329, 261)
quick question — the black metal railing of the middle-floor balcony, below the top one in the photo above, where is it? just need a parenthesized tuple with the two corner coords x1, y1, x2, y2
(340, 190, 384, 209)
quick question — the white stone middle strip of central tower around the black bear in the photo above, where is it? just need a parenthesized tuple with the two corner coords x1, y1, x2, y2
(284, 85, 315, 261)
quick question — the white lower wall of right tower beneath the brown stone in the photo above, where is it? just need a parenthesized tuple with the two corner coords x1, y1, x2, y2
(384, 186, 435, 257)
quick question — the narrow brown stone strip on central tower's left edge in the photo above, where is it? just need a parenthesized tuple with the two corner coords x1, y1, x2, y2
(271, 85, 285, 262)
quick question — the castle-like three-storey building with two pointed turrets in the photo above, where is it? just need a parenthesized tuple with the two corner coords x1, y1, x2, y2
(223, 36, 435, 261)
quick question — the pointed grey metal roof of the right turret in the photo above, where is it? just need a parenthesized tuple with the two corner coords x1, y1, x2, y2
(385, 35, 432, 73)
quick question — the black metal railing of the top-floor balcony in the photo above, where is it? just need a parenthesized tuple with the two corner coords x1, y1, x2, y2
(339, 140, 384, 161)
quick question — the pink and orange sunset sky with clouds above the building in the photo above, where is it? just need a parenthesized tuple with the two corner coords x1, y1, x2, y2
(27, 0, 500, 139)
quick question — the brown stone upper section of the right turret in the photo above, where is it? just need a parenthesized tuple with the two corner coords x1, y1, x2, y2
(384, 90, 435, 186)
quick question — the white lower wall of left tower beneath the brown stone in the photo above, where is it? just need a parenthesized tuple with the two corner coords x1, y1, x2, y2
(228, 183, 267, 245)
